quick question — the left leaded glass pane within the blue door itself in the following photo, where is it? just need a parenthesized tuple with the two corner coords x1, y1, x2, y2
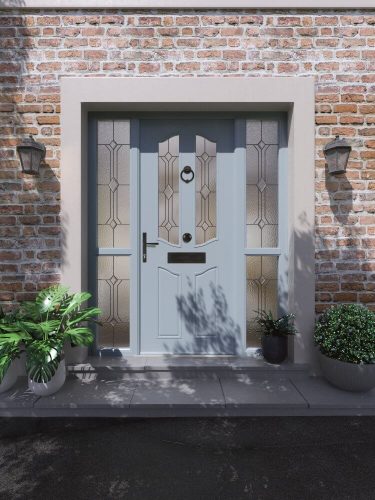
(158, 136, 180, 245)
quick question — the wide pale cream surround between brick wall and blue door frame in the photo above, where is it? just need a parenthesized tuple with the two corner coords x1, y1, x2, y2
(61, 77, 315, 363)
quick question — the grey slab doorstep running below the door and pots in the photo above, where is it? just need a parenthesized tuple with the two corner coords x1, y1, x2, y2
(0, 358, 375, 417)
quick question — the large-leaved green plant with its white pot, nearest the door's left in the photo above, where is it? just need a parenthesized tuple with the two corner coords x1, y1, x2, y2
(17, 285, 100, 396)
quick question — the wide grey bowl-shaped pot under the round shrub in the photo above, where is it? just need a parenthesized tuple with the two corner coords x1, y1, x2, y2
(319, 351, 375, 392)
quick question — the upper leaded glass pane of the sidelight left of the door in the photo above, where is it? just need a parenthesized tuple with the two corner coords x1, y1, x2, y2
(97, 119, 130, 248)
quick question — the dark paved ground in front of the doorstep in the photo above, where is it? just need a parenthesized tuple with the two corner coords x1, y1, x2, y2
(0, 417, 375, 500)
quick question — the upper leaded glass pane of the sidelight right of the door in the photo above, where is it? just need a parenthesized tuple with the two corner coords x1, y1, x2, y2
(246, 120, 279, 248)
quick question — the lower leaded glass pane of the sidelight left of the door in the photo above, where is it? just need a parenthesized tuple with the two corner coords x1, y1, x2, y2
(97, 255, 130, 348)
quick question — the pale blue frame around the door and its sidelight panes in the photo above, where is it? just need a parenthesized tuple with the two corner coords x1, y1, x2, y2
(87, 112, 289, 355)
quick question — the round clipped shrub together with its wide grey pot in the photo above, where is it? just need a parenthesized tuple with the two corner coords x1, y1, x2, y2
(314, 304, 375, 391)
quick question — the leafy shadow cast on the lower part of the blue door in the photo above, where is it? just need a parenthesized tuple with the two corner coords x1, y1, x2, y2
(164, 282, 243, 355)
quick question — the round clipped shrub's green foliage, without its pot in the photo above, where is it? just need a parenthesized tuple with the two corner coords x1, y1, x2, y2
(314, 304, 375, 363)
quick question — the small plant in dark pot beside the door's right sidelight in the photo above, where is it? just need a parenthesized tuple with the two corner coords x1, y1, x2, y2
(256, 311, 296, 364)
